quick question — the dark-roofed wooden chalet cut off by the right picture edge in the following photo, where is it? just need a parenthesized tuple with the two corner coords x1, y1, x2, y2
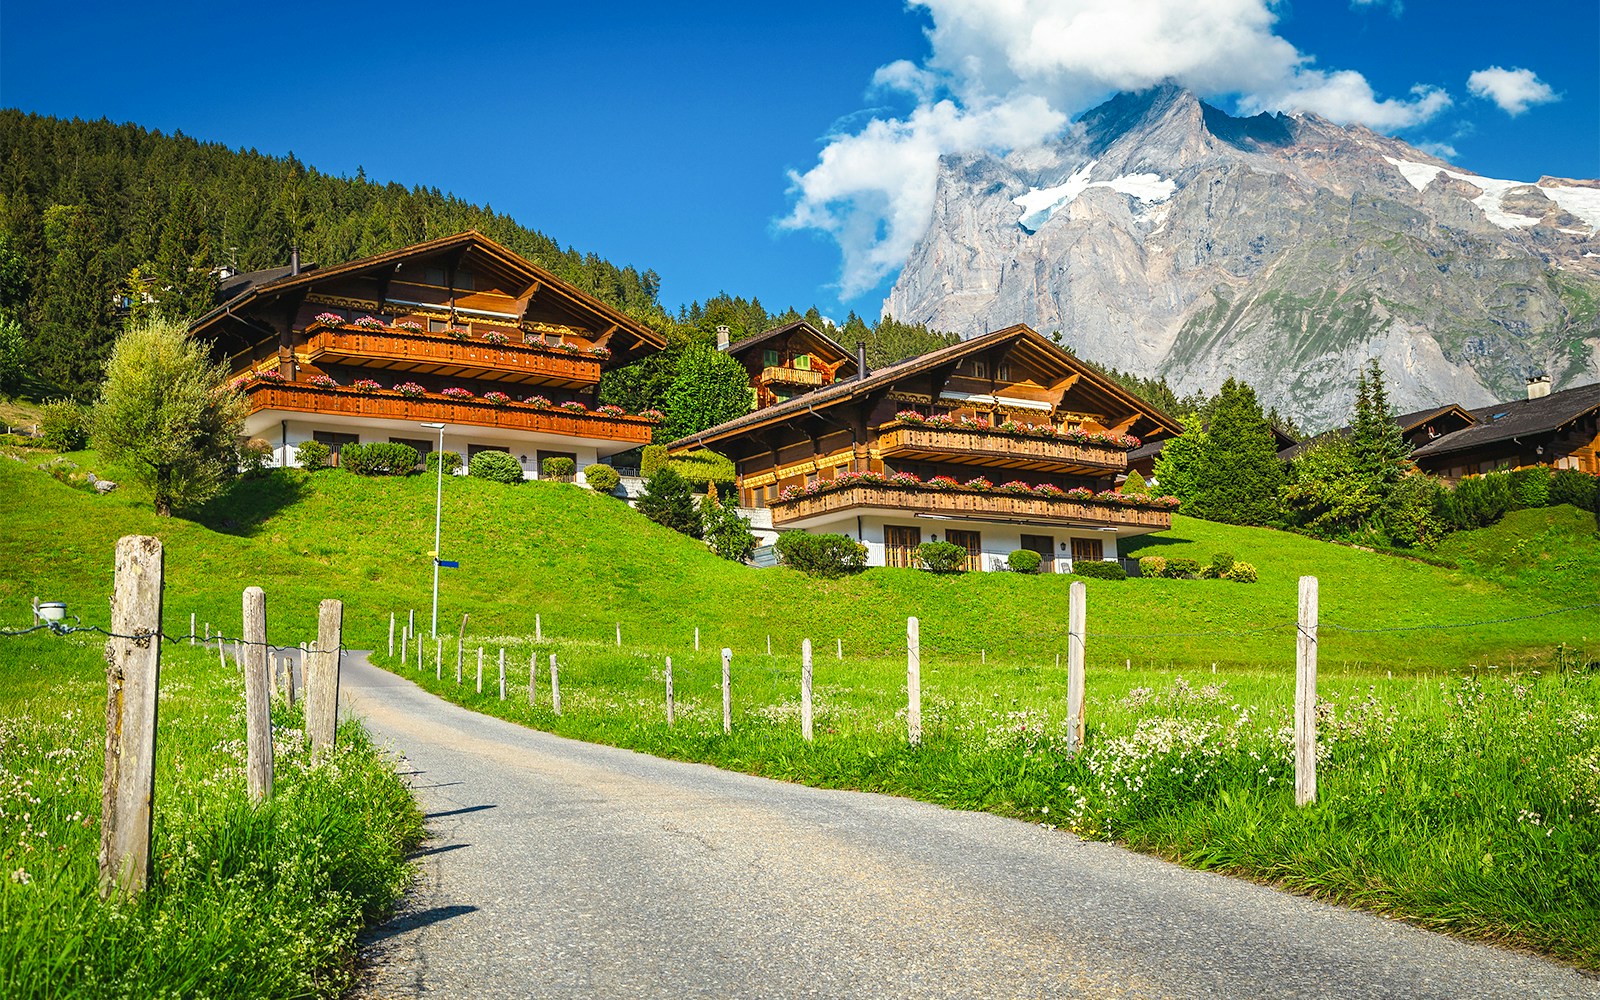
(1411, 378, 1600, 480)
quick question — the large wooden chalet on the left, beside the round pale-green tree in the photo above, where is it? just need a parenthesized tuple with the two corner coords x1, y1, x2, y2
(190, 232, 664, 477)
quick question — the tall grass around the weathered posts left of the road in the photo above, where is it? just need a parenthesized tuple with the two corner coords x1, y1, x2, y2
(0, 635, 421, 998)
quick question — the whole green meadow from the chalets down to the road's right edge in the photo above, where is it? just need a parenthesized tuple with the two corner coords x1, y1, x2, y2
(0, 456, 1600, 968)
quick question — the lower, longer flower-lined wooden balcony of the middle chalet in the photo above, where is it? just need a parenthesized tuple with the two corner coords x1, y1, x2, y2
(771, 483, 1173, 531)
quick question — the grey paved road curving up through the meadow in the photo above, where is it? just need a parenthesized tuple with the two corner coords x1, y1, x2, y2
(342, 658, 1600, 1000)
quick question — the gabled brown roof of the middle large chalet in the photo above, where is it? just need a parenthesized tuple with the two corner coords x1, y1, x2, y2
(667, 323, 1182, 450)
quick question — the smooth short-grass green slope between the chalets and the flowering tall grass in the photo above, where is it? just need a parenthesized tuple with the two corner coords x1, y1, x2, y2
(0, 461, 1600, 670)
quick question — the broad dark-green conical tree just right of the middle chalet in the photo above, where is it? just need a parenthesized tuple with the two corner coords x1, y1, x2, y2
(1186, 378, 1283, 525)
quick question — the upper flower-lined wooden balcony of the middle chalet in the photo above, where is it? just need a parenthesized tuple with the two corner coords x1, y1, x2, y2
(877, 424, 1128, 477)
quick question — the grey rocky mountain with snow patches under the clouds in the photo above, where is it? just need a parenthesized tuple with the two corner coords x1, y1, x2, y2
(883, 86, 1600, 429)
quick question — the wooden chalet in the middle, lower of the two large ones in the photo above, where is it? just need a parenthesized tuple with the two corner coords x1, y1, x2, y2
(670, 325, 1181, 571)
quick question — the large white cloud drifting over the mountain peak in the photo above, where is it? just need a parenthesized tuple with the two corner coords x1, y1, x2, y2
(779, 0, 1450, 298)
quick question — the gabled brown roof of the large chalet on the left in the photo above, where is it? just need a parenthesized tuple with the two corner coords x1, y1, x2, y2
(189, 229, 666, 358)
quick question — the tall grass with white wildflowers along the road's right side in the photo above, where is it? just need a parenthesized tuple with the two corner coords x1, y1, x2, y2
(378, 635, 1600, 970)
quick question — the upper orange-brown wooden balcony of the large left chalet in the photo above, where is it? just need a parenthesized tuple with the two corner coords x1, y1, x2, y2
(296, 326, 600, 389)
